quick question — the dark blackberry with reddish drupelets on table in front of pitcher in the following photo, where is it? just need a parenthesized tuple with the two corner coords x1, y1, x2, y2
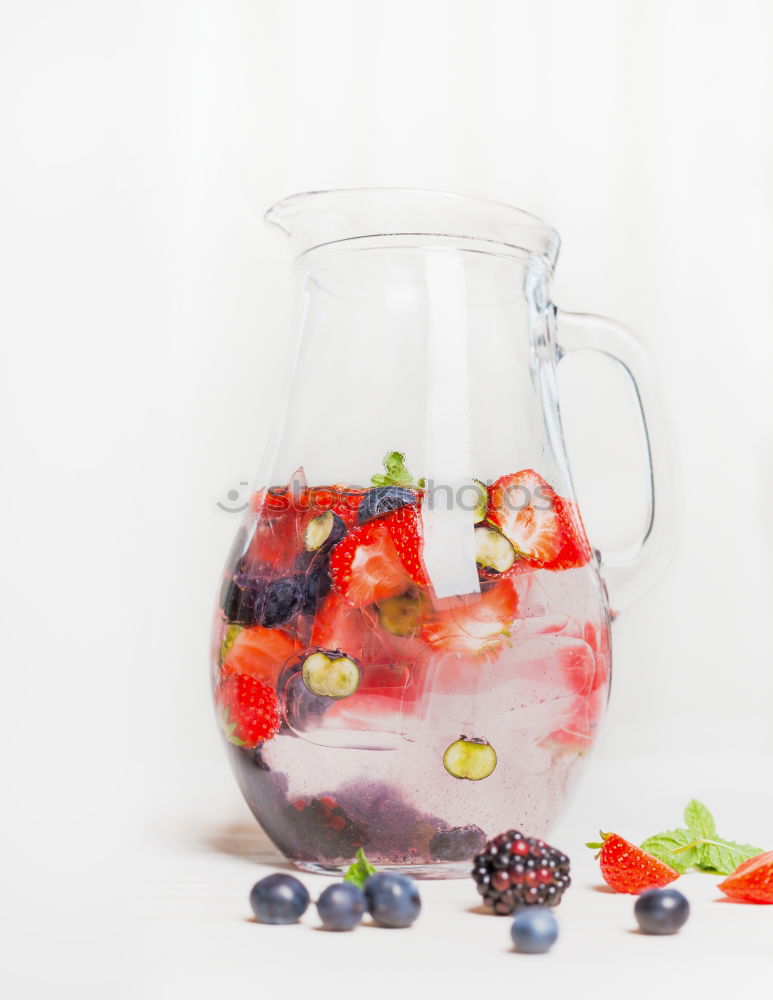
(472, 830, 571, 916)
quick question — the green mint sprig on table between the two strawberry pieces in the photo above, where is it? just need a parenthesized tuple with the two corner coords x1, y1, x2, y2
(641, 799, 762, 875)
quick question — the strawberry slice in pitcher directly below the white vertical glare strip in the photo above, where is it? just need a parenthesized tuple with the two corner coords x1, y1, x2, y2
(421, 579, 518, 653)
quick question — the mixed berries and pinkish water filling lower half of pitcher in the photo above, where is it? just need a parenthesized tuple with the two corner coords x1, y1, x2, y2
(213, 452, 610, 875)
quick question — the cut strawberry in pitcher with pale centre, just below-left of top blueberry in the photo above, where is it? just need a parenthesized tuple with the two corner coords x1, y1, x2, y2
(330, 519, 410, 608)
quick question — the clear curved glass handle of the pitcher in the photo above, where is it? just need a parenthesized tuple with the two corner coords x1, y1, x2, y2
(555, 309, 674, 614)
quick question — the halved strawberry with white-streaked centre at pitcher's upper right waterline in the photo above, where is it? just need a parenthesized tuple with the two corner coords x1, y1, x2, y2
(488, 469, 566, 565)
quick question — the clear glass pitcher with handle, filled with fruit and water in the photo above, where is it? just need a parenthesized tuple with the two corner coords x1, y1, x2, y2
(212, 189, 667, 877)
